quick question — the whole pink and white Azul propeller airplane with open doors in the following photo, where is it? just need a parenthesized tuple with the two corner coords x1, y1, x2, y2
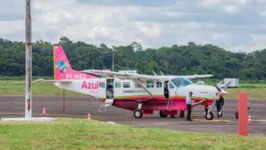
(38, 45, 227, 120)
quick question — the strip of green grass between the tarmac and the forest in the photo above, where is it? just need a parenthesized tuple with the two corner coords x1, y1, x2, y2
(0, 80, 266, 99)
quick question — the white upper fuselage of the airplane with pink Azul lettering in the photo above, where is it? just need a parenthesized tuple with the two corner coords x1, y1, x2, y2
(55, 78, 218, 100)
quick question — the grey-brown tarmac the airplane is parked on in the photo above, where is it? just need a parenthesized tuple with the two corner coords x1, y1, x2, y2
(0, 96, 266, 136)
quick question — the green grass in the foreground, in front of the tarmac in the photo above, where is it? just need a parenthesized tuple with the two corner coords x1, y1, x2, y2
(0, 118, 266, 150)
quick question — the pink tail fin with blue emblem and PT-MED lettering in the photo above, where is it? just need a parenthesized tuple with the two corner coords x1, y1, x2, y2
(53, 45, 96, 80)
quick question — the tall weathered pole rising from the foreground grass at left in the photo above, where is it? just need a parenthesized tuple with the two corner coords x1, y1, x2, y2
(25, 0, 32, 118)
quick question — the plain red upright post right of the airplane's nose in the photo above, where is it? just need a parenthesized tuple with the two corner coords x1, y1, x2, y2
(238, 92, 248, 136)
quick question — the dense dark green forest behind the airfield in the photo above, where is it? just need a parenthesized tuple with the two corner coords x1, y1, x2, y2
(0, 37, 266, 80)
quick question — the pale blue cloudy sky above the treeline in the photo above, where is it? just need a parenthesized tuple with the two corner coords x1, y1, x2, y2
(0, 0, 266, 52)
